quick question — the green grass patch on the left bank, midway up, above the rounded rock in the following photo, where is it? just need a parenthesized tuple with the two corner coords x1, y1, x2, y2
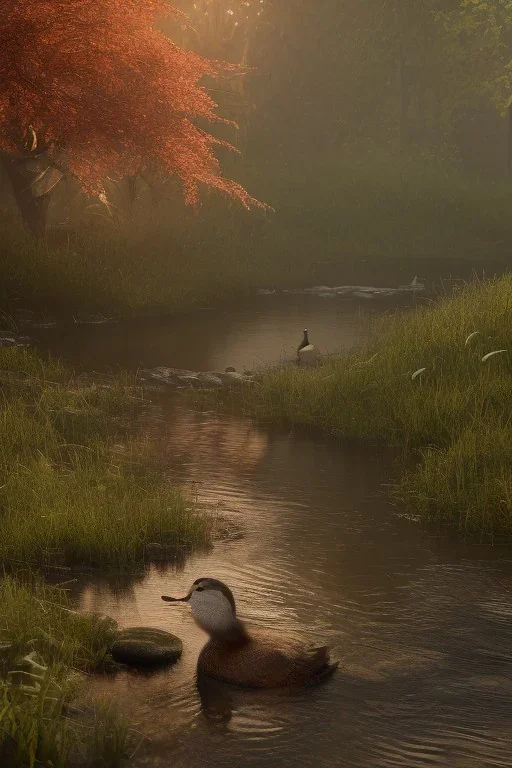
(0, 348, 208, 567)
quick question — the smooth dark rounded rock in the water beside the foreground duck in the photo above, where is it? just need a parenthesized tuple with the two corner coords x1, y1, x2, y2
(111, 627, 183, 667)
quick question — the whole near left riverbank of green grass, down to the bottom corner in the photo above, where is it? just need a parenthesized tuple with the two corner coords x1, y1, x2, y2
(0, 347, 210, 768)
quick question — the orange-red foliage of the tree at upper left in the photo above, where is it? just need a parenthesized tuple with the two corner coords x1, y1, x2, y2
(0, 0, 261, 235)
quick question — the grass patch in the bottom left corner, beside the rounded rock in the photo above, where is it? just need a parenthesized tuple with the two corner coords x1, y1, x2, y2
(0, 576, 134, 768)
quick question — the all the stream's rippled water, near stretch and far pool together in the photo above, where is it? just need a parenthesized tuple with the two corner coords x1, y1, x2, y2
(31, 296, 512, 768)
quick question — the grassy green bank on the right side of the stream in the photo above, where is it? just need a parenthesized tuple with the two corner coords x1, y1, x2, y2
(236, 275, 512, 541)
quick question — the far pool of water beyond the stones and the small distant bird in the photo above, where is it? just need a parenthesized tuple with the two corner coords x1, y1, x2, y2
(30, 295, 421, 372)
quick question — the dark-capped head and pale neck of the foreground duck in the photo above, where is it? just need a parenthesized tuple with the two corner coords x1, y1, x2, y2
(162, 578, 243, 638)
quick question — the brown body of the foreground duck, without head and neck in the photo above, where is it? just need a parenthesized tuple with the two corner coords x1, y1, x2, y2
(197, 627, 338, 688)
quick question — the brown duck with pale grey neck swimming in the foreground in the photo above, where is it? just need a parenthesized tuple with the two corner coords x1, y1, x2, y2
(162, 578, 339, 688)
